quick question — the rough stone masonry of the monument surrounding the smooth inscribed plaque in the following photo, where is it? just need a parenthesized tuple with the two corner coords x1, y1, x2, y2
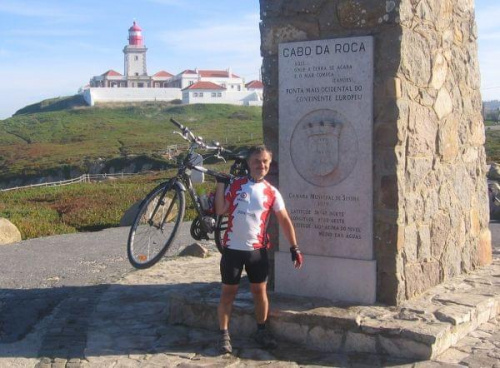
(260, 0, 491, 304)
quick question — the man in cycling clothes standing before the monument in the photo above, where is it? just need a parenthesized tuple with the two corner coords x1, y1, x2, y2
(215, 146, 303, 354)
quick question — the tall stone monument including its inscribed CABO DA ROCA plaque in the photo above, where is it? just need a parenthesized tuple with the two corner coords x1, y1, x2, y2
(260, 0, 491, 304)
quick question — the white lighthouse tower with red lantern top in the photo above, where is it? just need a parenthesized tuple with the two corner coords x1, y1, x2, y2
(123, 21, 149, 88)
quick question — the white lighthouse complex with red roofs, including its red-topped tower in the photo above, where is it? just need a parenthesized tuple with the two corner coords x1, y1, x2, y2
(81, 22, 264, 106)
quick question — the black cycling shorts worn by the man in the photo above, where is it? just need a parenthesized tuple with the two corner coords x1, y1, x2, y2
(220, 248, 269, 285)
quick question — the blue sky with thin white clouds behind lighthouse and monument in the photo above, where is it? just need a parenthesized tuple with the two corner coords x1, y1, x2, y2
(0, 0, 500, 119)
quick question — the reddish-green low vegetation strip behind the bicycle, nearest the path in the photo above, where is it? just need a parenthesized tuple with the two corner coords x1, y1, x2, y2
(0, 166, 220, 239)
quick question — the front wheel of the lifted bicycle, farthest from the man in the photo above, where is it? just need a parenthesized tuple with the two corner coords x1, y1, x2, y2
(127, 181, 185, 269)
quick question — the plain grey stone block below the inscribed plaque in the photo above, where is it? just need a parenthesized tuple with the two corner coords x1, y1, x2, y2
(274, 251, 377, 304)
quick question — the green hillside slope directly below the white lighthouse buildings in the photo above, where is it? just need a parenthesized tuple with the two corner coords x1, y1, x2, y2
(0, 98, 262, 182)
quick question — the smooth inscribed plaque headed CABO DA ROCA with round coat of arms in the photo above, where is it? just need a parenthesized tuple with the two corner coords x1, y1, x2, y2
(279, 37, 373, 260)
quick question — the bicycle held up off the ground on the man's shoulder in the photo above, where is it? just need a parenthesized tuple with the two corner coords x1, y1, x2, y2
(127, 119, 247, 269)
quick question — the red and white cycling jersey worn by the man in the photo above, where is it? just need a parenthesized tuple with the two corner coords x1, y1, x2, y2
(223, 177, 285, 251)
